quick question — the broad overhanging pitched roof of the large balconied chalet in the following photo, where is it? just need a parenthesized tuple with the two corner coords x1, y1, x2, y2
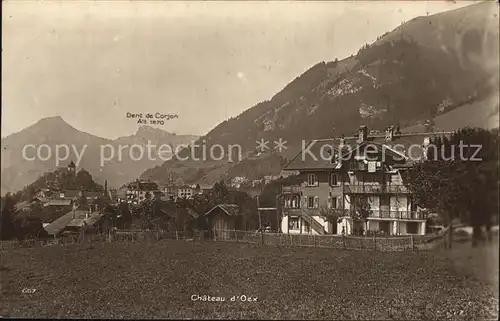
(283, 132, 452, 170)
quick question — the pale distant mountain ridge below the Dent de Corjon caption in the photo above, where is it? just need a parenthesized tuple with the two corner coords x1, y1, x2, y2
(1, 116, 198, 194)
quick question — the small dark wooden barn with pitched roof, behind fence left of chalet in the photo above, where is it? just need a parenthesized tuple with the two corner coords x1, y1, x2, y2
(205, 204, 242, 239)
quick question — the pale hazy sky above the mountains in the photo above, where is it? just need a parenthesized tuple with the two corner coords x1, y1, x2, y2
(1, 0, 473, 138)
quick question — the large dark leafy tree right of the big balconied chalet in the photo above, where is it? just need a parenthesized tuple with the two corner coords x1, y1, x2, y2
(408, 128, 499, 247)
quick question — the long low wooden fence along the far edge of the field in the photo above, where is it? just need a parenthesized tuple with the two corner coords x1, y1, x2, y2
(1, 226, 443, 251)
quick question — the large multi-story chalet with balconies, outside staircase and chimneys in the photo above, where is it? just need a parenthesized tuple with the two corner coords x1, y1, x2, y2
(281, 126, 451, 235)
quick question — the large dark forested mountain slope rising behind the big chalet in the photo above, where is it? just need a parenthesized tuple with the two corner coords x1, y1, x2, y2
(142, 3, 498, 186)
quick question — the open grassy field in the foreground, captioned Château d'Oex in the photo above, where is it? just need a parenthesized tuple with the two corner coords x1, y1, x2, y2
(0, 241, 498, 320)
